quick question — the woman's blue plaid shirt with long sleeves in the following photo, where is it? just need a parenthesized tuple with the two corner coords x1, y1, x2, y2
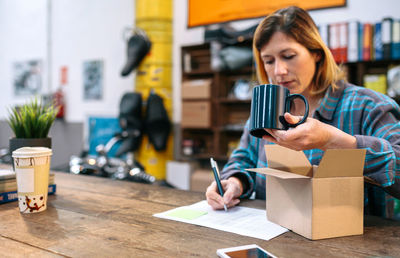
(221, 83, 400, 219)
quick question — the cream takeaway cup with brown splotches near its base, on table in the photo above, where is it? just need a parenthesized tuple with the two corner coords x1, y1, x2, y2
(12, 147, 52, 213)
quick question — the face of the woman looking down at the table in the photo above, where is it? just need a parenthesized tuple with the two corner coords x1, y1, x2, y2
(260, 32, 317, 95)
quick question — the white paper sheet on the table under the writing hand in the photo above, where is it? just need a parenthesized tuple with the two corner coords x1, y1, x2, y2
(153, 200, 288, 240)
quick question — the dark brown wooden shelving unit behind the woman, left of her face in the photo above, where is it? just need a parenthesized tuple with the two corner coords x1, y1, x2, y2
(181, 42, 255, 160)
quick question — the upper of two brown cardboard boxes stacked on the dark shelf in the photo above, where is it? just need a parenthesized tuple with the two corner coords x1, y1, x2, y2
(182, 79, 212, 99)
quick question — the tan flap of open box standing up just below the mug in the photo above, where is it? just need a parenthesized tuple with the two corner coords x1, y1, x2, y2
(264, 145, 313, 177)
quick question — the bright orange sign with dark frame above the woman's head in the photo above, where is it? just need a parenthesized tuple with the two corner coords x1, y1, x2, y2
(187, 0, 346, 28)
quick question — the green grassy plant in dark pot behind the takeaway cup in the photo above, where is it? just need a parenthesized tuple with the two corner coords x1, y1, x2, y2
(7, 98, 58, 154)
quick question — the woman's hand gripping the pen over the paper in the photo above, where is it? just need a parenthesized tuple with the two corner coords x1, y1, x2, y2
(206, 177, 243, 210)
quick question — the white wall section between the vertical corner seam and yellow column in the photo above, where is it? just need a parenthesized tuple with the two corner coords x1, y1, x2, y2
(52, 0, 134, 121)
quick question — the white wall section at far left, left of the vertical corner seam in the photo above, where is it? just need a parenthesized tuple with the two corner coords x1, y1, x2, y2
(0, 0, 47, 115)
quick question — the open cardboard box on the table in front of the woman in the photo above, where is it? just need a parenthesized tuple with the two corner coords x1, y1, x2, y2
(249, 145, 365, 240)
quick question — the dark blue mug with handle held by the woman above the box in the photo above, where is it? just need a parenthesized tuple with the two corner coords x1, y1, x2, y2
(250, 84, 308, 138)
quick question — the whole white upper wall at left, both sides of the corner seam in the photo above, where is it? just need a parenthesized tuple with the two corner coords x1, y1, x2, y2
(0, 0, 135, 122)
